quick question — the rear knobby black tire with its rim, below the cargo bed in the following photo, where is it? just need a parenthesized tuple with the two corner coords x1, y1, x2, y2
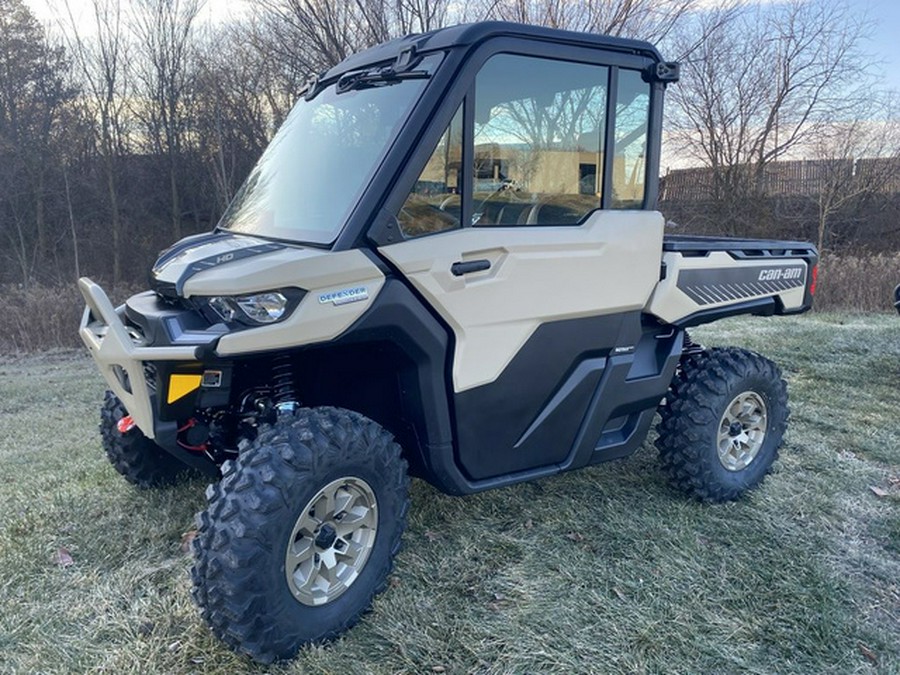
(656, 347, 789, 502)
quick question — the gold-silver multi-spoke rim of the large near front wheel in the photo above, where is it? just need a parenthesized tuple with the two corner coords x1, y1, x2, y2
(284, 476, 378, 606)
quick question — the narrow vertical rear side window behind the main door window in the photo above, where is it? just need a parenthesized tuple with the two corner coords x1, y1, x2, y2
(610, 69, 650, 209)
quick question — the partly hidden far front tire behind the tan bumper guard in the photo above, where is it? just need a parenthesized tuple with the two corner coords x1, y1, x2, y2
(100, 391, 191, 489)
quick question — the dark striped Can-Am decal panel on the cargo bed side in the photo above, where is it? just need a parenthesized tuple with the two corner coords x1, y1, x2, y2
(676, 264, 806, 305)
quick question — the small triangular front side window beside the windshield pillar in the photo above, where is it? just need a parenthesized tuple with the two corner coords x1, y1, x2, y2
(397, 106, 462, 237)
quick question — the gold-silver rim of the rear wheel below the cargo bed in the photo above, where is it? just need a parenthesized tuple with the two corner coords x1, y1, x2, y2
(716, 391, 768, 471)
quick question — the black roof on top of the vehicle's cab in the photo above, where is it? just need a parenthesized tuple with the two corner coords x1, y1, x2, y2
(323, 21, 662, 79)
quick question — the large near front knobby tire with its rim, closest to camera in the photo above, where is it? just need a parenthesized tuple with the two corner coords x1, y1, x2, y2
(191, 408, 409, 663)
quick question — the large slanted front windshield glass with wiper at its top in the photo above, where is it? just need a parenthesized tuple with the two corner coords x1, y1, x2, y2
(219, 55, 440, 244)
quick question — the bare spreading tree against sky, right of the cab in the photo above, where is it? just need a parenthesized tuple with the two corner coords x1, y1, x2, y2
(670, 0, 866, 205)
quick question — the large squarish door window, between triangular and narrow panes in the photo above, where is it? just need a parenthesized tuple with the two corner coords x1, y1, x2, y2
(472, 54, 609, 226)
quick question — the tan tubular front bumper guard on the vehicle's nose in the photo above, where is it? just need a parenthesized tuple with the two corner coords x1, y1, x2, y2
(78, 277, 200, 438)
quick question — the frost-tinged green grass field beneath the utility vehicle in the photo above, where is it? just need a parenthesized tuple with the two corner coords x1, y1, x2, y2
(0, 314, 900, 674)
